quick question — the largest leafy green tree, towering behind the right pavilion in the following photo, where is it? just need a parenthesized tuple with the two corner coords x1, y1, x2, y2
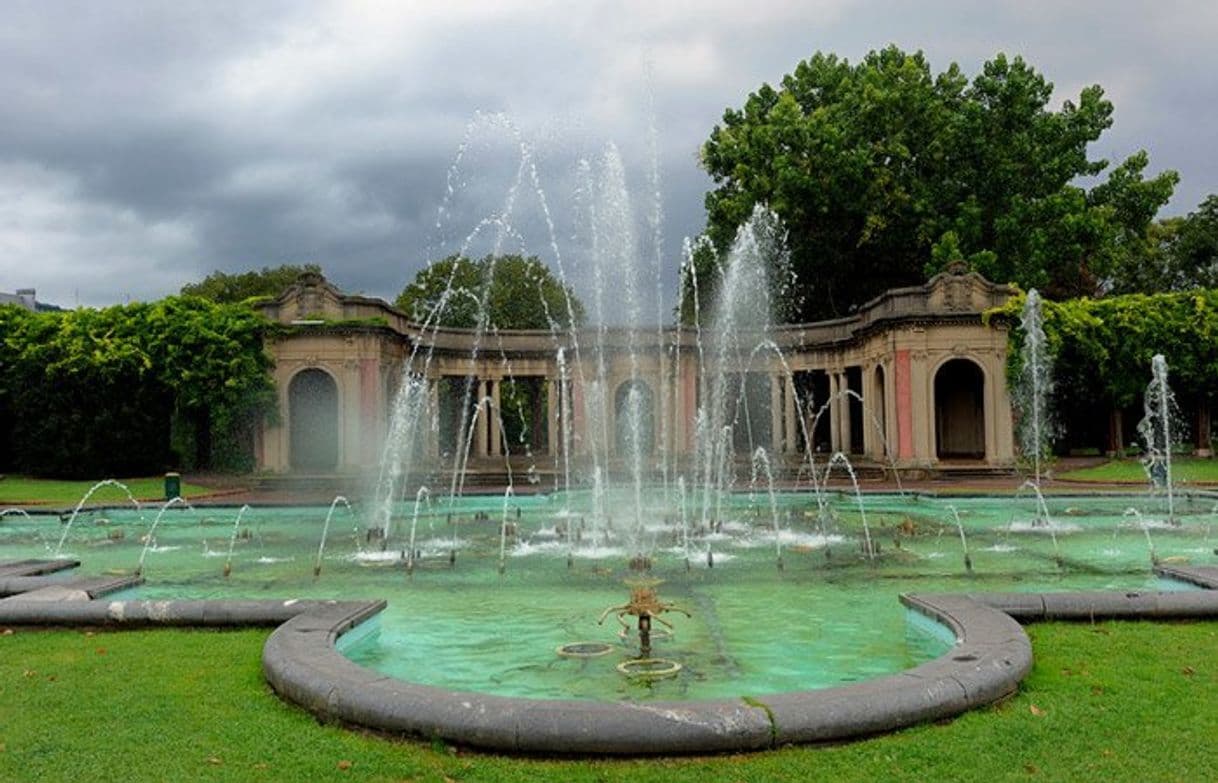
(699, 46, 1177, 320)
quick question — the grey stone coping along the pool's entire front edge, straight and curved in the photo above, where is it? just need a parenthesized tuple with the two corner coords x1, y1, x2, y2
(0, 564, 1218, 755)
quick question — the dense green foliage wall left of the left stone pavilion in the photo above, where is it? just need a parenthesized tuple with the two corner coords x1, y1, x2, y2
(0, 296, 274, 477)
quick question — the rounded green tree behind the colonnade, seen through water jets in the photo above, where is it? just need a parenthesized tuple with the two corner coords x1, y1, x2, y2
(393, 256, 583, 329)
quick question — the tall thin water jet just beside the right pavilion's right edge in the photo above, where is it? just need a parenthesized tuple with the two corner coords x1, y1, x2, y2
(1015, 289, 1054, 486)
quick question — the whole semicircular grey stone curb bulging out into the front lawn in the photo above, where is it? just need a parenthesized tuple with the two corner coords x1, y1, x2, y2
(262, 595, 1032, 755)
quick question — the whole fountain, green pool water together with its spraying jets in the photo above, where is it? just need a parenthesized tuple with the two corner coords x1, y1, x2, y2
(7, 119, 1208, 746)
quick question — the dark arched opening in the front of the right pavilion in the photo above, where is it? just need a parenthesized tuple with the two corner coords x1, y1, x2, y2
(934, 359, 985, 459)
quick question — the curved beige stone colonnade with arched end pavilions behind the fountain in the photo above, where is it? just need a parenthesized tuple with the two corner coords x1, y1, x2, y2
(258, 267, 1015, 472)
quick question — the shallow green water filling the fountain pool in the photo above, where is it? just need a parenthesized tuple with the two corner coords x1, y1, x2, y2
(0, 493, 1218, 700)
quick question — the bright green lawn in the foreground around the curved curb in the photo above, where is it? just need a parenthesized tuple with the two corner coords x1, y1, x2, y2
(0, 622, 1218, 783)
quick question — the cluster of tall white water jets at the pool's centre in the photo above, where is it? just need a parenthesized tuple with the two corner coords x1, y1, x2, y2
(360, 124, 896, 567)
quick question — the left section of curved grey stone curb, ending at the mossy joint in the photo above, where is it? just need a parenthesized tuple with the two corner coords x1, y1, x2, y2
(262, 613, 772, 754)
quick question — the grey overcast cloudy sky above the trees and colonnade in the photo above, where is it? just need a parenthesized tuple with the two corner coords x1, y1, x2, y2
(0, 0, 1218, 312)
